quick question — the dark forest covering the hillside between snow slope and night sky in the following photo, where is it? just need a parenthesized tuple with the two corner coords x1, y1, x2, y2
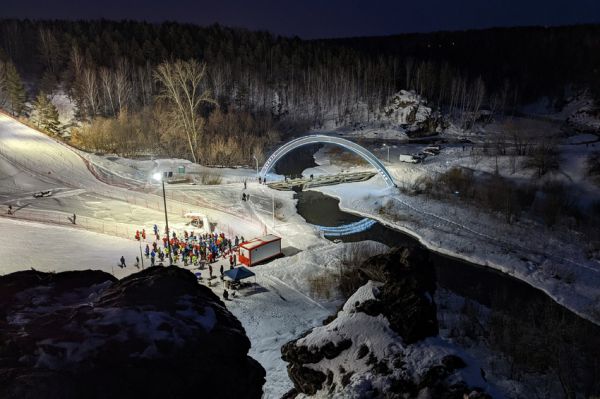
(0, 20, 600, 165)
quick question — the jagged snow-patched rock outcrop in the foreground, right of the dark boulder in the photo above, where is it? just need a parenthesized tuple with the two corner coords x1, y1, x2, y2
(282, 248, 489, 398)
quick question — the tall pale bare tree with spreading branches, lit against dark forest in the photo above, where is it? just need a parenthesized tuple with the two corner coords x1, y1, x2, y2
(155, 60, 216, 163)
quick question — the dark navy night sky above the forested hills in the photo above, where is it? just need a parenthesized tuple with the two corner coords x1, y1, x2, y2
(0, 0, 600, 38)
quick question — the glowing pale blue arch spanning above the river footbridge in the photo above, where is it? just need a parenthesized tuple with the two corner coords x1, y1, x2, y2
(260, 134, 396, 187)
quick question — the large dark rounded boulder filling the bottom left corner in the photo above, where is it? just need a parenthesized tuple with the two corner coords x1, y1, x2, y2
(0, 267, 265, 399)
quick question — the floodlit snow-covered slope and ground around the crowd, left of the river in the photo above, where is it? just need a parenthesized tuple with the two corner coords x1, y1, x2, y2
(0, 115, 350, 398)
